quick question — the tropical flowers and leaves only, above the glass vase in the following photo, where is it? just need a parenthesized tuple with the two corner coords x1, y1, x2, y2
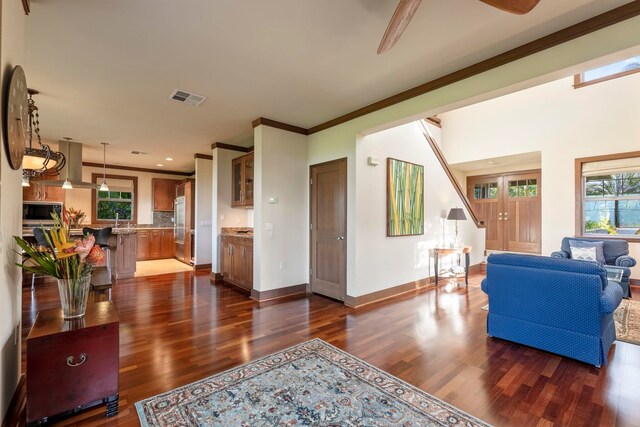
(13, 214, 106, 279)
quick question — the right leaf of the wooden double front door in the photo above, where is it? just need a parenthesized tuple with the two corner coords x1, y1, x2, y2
(503, 172, 542, 253)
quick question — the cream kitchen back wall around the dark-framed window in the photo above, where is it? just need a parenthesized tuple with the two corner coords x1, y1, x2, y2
(64, 166, 187, 224)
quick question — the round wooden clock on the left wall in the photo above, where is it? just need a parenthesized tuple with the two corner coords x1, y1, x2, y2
(4, 65, 29, 169)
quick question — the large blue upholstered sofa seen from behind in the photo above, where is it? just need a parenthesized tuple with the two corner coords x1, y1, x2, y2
(482, 254, 622, 367)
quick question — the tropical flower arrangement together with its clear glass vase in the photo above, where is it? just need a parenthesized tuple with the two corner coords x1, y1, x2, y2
(13, 214, 106, 319)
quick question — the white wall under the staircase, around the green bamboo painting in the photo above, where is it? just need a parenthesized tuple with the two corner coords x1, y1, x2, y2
(356, 123, 484, 296)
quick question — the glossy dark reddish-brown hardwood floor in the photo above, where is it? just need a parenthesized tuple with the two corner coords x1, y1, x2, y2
(23, 272, 640, 426)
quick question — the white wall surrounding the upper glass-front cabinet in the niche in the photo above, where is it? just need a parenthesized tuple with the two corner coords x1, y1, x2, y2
(209, 148, 250, 273)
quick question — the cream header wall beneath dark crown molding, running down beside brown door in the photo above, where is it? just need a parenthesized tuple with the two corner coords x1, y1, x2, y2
(307, 17, 640, 296)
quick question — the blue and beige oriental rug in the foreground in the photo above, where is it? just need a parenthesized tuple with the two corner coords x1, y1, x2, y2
(136, 338, 488, 427)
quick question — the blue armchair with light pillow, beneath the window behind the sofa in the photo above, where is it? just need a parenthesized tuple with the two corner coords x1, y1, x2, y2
(551, 237, 636, 298)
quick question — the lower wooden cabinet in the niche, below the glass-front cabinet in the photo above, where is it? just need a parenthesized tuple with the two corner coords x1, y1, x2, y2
(221, 236, 253, 290)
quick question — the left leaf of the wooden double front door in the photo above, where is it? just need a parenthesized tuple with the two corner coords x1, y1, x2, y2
(467, 176, 504, 250)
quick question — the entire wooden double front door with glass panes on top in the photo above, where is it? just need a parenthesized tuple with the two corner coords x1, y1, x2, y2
(467, 171, 542, 253)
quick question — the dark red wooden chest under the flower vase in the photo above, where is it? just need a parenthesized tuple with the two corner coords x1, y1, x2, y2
(27, 301, 119, 424)
